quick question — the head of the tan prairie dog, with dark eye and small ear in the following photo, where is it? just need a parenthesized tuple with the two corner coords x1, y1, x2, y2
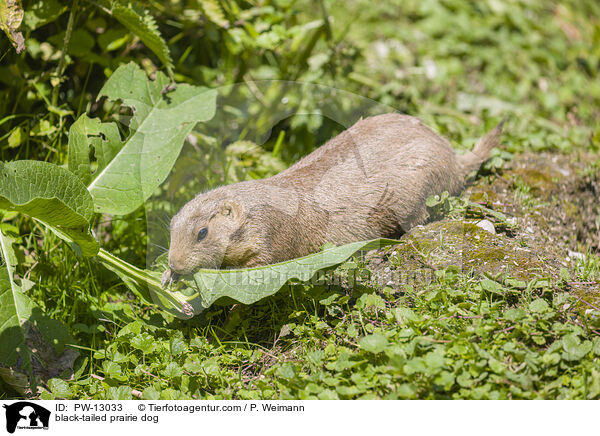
(163, 193, 245, 282)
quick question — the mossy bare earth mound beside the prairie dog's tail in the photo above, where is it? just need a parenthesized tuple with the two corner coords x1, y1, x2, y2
(367, 153, 600, 296)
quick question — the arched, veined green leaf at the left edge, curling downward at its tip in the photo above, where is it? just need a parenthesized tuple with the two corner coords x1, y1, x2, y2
(0, 160, 98, 256)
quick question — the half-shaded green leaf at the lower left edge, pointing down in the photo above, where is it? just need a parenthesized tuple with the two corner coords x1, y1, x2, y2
(0, 228, 74, 390)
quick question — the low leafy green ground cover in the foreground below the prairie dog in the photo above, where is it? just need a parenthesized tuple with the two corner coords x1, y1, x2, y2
(32, 263, 600, 399)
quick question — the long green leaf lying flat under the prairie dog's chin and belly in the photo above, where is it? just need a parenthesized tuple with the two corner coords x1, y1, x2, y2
(151, 239, 400, 316)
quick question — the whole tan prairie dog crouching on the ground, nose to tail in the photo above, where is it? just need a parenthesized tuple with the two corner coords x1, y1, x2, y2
(162, 114, 501, 279)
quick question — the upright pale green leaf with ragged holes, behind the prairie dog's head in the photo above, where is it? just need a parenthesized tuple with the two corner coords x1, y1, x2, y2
(69, 63, 217, 215)
